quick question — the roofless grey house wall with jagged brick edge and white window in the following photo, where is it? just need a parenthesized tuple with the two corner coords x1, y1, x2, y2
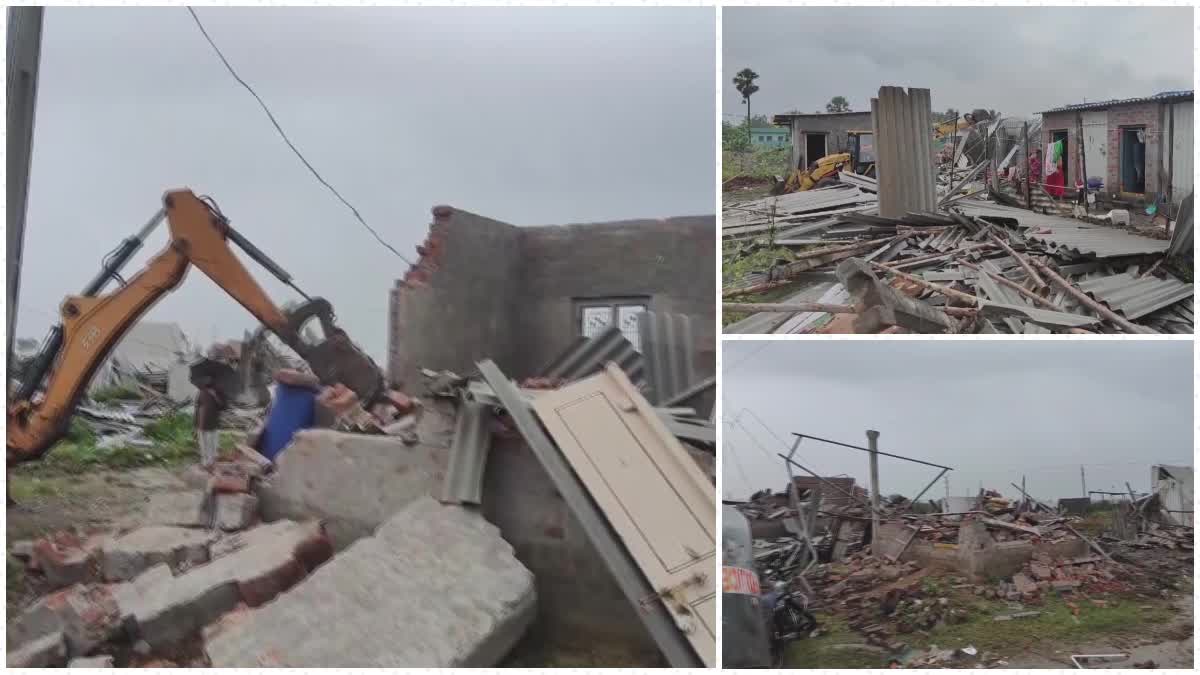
(388, 207, 716, 390)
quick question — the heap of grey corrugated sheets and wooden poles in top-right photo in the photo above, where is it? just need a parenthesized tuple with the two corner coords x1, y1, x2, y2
(722, 88, 1195, 334)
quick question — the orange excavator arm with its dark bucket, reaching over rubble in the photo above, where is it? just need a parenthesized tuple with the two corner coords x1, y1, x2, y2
(7, 190, 383, 466)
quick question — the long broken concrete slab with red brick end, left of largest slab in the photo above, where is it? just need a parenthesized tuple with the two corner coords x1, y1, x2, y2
(121, 521, 332, 649)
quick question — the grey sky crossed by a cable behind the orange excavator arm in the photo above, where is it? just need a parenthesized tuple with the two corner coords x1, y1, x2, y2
(17, 7, 716, 364)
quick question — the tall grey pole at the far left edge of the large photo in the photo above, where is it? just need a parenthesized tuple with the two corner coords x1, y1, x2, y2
(5, 7, 44, 386)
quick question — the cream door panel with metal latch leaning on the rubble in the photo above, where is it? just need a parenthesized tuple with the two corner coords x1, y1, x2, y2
(533, 364, 716, 667)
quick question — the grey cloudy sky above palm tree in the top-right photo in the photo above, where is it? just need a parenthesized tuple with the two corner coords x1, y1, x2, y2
(721, 7, 1194, 123)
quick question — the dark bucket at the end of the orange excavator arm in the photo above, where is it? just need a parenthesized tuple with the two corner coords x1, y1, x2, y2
(280, 298, 384, 406)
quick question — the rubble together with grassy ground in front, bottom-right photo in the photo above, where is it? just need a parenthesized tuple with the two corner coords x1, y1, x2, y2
(738, 482, 1194, 668)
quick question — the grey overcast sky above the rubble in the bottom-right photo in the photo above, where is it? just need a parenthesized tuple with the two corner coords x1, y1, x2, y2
(721, 340, 1194, 500)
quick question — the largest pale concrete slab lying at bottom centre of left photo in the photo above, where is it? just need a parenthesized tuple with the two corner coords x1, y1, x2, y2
(208, 497, 536, 668)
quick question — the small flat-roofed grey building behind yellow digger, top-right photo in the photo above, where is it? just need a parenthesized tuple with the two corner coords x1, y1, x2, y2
(770, 110, 875, 171)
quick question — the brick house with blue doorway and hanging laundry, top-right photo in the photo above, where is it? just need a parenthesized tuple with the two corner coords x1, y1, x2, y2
(1042, 90, 1194, 208)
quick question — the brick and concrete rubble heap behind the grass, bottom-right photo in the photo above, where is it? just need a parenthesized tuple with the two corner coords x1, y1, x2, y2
(736, 478, 1193, 668)
